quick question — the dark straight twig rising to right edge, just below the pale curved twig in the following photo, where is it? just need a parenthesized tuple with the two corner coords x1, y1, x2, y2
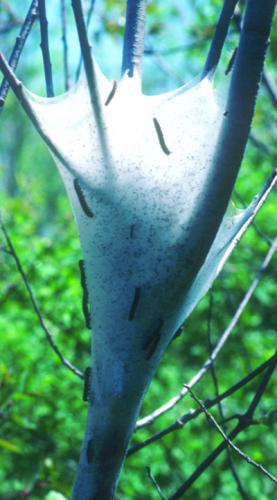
(127, 356, 274, 456)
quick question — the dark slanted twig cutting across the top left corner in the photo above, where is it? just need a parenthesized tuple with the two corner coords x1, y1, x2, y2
(0, 0, 38, 112)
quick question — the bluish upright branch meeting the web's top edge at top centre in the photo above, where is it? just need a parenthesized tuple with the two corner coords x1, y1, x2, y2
(122, 0, 146, 77)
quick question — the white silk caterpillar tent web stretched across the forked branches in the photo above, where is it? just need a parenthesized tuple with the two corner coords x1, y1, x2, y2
(1, 0, 273, 499)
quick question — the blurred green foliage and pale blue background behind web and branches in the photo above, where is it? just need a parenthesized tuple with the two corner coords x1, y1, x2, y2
(0, 0, 277, 500)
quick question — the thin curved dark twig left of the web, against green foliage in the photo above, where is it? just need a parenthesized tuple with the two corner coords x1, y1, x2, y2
(0, 218, 83, 378)
